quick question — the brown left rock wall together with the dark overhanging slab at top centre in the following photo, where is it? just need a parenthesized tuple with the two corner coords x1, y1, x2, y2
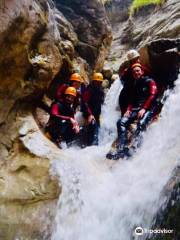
(0, 0, 111, 240)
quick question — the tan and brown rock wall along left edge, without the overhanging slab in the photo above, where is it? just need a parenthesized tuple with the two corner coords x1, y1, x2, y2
(0, 0, 62, 239)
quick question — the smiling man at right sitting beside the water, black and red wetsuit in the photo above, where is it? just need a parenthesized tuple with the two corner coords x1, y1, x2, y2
(117, 63, 157, 158)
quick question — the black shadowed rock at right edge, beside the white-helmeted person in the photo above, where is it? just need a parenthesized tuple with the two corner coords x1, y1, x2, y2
(139, 39, 180, 89)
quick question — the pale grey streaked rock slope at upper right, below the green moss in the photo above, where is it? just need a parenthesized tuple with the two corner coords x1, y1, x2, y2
(124, 0, 180, 46)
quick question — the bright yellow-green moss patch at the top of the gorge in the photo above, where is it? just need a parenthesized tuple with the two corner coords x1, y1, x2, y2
(129, 0, 164, 15)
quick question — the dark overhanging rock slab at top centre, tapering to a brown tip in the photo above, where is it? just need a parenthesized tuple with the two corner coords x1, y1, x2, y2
(56, 0, 112, 70)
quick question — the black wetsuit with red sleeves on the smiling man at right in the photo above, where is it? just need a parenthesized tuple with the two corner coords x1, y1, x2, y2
(117, 76, 157, 150)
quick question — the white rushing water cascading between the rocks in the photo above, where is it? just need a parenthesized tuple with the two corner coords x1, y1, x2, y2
(52, 75, 180, 240)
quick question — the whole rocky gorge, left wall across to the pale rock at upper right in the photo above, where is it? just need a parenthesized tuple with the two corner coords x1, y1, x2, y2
(0, 0, 180, 240)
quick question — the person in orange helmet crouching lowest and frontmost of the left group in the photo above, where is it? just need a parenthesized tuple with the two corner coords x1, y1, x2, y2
(47, 87, 80, 145)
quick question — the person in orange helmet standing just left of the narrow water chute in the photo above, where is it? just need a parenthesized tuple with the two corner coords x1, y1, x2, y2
(82, 73, 104, 146)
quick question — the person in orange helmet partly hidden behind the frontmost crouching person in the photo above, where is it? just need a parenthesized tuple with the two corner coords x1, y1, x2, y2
(56, 73, 83, 109)
